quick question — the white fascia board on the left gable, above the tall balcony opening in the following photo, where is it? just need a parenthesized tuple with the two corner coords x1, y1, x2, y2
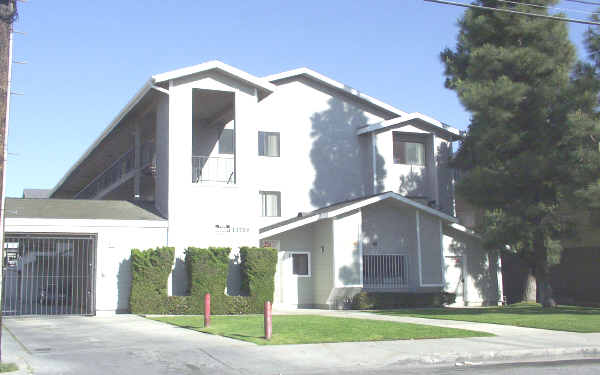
(152, 60, 277, 93)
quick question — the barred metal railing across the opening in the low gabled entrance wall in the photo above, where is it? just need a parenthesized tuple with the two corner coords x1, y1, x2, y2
(363, 255, 408, 289)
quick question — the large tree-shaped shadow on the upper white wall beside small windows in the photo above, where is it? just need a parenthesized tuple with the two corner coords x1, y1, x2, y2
(310, 97, 386, 207)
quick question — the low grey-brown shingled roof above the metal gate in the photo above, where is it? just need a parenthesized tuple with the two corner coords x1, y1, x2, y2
(4, 198, 165, 220)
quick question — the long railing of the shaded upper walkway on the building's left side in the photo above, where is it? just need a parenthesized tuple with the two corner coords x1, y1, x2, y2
(75, 142, 155, 199)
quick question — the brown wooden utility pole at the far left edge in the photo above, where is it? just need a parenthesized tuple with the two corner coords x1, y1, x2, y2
(0, 0, 17, 362)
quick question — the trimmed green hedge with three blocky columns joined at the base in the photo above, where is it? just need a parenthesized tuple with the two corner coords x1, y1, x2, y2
(129, 247, 277, 314)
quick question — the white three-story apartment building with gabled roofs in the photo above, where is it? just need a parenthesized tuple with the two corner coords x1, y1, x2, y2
(6, 61, 502, 312)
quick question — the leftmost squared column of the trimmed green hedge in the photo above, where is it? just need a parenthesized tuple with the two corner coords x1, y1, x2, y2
(129, 247, 175, 313)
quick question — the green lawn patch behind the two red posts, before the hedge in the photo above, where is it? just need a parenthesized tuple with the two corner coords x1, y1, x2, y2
(151, 315, 493, 345)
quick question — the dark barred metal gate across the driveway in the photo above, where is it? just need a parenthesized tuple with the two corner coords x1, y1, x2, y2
(2, 233, 96, 316)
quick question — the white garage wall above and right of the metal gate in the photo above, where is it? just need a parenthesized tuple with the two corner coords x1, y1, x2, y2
(5, 218, 167, 315)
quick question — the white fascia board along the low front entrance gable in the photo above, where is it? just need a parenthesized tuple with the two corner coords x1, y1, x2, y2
(259, 192, 458, 239)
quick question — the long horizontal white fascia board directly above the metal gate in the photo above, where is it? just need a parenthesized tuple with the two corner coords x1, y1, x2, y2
(5, 218, 169, 232)
